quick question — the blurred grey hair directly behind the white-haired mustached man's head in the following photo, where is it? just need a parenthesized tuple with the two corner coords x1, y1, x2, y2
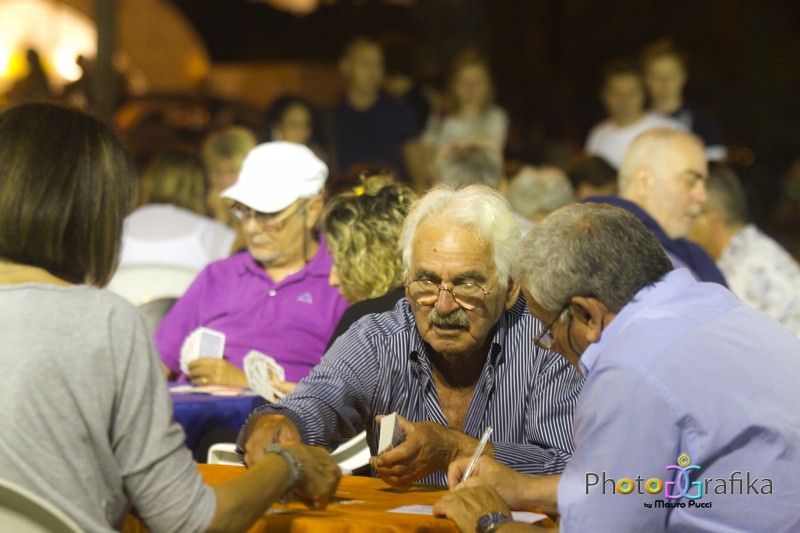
(436, 141, 503, 189)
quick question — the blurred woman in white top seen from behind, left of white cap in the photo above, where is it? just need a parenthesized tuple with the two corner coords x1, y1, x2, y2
(120, 150, 235, 272)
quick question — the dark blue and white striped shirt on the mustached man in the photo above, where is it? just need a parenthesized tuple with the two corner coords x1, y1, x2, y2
(239, 298, 583, 485)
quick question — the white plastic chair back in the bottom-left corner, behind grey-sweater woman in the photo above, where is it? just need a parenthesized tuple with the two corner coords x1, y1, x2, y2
(0, 479, 81, 533)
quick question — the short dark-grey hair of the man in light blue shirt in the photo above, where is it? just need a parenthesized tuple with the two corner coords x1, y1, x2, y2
(513, 203, 672, 312)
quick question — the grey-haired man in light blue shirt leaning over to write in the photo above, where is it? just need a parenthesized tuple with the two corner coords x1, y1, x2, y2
(434, 203, 800, 533)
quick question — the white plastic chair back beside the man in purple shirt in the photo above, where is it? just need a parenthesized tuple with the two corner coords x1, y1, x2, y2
(107, 264, 198, 306)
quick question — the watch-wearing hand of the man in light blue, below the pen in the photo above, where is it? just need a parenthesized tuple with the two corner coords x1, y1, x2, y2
(433, 478, 511, 532)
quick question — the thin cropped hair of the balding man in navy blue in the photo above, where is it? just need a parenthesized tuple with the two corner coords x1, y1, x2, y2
(617, 128, 703, 196)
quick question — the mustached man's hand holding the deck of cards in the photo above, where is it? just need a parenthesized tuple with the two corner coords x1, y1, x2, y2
(370, 415, 493, 486)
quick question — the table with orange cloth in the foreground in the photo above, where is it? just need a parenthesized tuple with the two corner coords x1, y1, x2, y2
(122, 464, 458, 533)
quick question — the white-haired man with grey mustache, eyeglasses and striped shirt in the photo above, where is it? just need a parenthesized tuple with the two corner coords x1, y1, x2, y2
(239, 186, 582, 486)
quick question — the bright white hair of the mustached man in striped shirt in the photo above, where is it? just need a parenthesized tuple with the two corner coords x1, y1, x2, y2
(400, 185, 520, 289)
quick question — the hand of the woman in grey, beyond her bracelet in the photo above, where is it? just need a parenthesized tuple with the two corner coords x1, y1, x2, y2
(286, 443, 342, 509)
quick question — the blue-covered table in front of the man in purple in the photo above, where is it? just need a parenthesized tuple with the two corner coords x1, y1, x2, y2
(170, 393, 264, 452)
